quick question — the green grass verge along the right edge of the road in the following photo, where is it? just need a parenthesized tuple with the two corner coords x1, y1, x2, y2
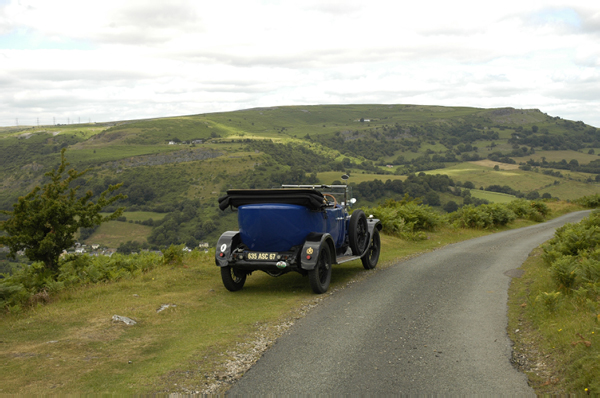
(508, 249, 600, 395)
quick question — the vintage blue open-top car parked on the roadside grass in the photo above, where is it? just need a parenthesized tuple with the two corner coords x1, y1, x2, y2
(215, 185, 382, 293)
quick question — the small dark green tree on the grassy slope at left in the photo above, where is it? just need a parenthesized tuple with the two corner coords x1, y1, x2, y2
(0, 148, 126, 274)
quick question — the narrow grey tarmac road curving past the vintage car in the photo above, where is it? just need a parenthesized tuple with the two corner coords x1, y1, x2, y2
(228, 212, 588, 395)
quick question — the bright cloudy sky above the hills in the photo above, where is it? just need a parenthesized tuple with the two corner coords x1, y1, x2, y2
(0, 0, 600, 127)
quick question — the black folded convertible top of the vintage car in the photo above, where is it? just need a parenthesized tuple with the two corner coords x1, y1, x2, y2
(219, 188, 327, 210)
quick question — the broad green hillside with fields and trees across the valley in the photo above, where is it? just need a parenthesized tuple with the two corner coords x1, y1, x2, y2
(0, 105, 600, 247)
